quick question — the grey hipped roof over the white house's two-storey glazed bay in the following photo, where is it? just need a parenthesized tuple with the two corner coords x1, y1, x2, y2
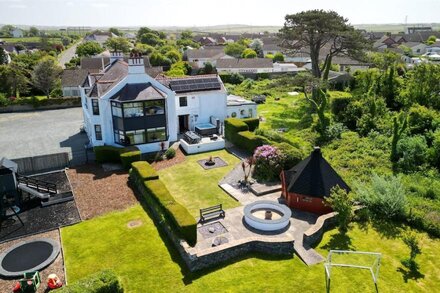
(110, 82, 166, 102)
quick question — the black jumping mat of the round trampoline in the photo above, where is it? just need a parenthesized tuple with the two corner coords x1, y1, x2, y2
(1, 241, 54, 272)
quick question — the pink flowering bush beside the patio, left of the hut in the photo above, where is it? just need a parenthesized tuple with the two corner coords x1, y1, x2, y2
(253, 145, 282, 181)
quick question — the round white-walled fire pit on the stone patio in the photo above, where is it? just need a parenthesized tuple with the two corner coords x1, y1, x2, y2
(244, 200, 292, 231)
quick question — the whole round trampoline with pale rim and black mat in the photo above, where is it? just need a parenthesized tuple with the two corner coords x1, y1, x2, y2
(0, 238, 60, 277)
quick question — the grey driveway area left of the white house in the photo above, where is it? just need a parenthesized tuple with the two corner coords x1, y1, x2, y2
(0, 108, 88, 164)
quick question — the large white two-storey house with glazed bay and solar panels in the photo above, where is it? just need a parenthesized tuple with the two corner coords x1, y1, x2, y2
(81, 53, 227, 153)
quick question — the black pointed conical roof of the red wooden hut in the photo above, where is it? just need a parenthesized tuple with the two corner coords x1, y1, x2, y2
(284, 148, 350, 198)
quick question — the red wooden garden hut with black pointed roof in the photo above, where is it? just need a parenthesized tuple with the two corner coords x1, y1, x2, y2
(281, 147, 350, 214)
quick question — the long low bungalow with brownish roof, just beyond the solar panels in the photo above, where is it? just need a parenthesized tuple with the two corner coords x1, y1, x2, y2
(217, 58, 273, 74)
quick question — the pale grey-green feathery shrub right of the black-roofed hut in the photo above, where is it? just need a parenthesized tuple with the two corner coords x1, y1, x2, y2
(356, 173, 406, 219)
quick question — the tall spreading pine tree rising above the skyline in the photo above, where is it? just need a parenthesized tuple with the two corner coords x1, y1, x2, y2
(280, 10, 369, 80)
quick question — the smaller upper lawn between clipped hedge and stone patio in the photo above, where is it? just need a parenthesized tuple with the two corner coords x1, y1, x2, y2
(159, 150, 240, 216)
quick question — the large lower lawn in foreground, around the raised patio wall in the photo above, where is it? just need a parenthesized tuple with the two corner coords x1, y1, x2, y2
(61, 205, 440, 292)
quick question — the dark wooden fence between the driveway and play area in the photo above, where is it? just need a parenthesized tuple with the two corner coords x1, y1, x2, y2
(12, 152, 69, 174)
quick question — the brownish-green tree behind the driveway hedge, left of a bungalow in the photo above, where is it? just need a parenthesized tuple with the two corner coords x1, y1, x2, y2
(32, 58, 63, 98)
